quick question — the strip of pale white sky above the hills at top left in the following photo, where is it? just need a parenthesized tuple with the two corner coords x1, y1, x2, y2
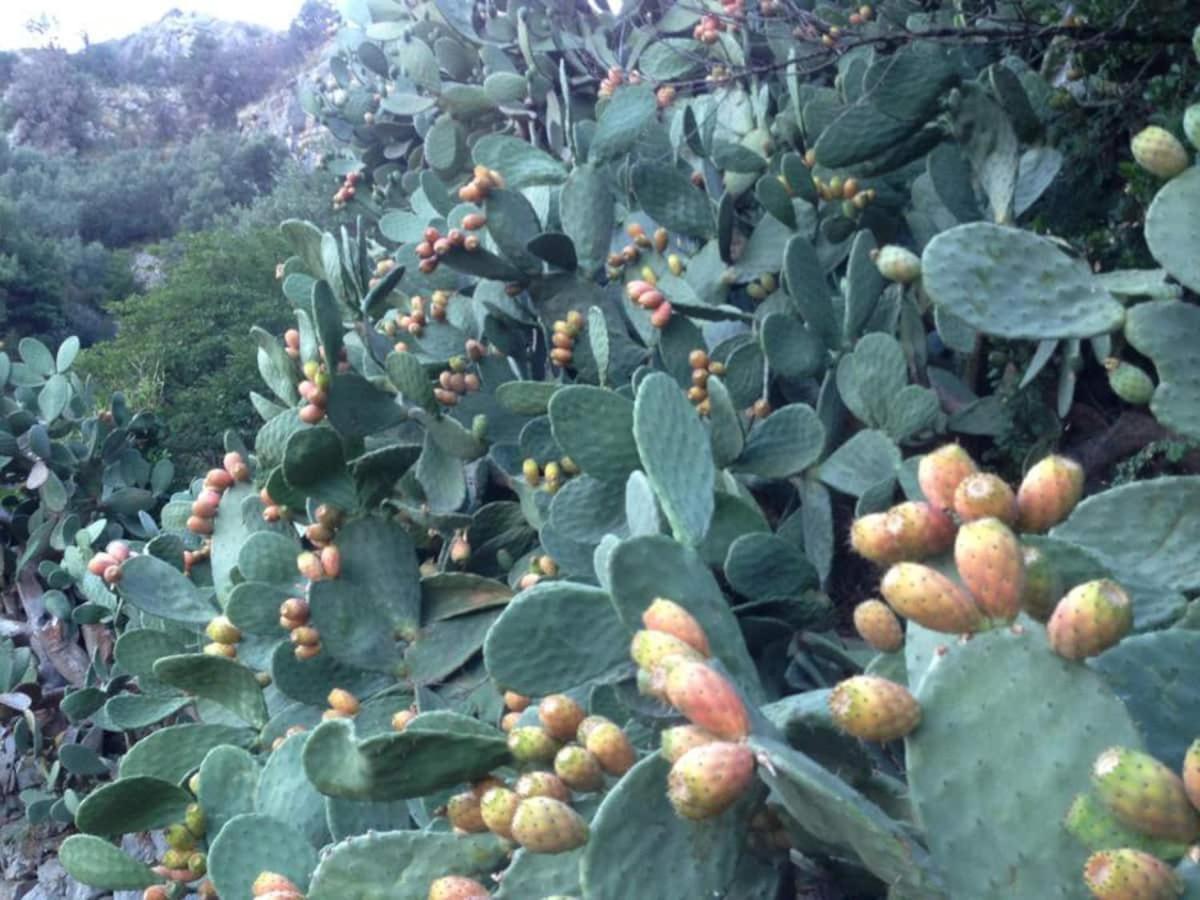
(0, 0, 304, 50)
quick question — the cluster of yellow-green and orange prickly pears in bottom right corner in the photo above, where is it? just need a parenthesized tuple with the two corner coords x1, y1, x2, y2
(1066, 742, 1200, 900)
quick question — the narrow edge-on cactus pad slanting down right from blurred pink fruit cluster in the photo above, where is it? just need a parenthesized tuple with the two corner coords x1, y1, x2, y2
(750, 737, 950, 900)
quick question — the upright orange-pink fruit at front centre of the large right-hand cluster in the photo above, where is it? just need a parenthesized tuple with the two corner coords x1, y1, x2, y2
(954, 518, 1025, 622)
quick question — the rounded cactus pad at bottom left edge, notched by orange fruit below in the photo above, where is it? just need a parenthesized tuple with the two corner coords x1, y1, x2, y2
(208, 814, 317, 896)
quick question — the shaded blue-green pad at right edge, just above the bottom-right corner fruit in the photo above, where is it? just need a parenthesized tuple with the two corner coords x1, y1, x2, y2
(1088, 629, 1200, 772)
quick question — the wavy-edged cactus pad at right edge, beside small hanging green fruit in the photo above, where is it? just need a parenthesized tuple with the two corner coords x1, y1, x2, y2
(1126, 303, 1200, 438)
